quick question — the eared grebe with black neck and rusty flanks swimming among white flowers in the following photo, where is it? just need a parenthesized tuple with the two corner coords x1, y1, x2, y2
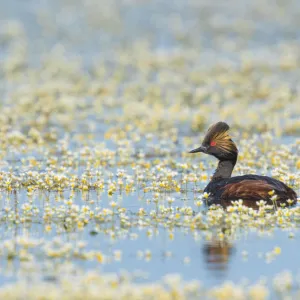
(190, 122, 297, 208)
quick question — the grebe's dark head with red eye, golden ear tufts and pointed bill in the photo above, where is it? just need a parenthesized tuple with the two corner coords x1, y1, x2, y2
(189, 122, 238, 161)
